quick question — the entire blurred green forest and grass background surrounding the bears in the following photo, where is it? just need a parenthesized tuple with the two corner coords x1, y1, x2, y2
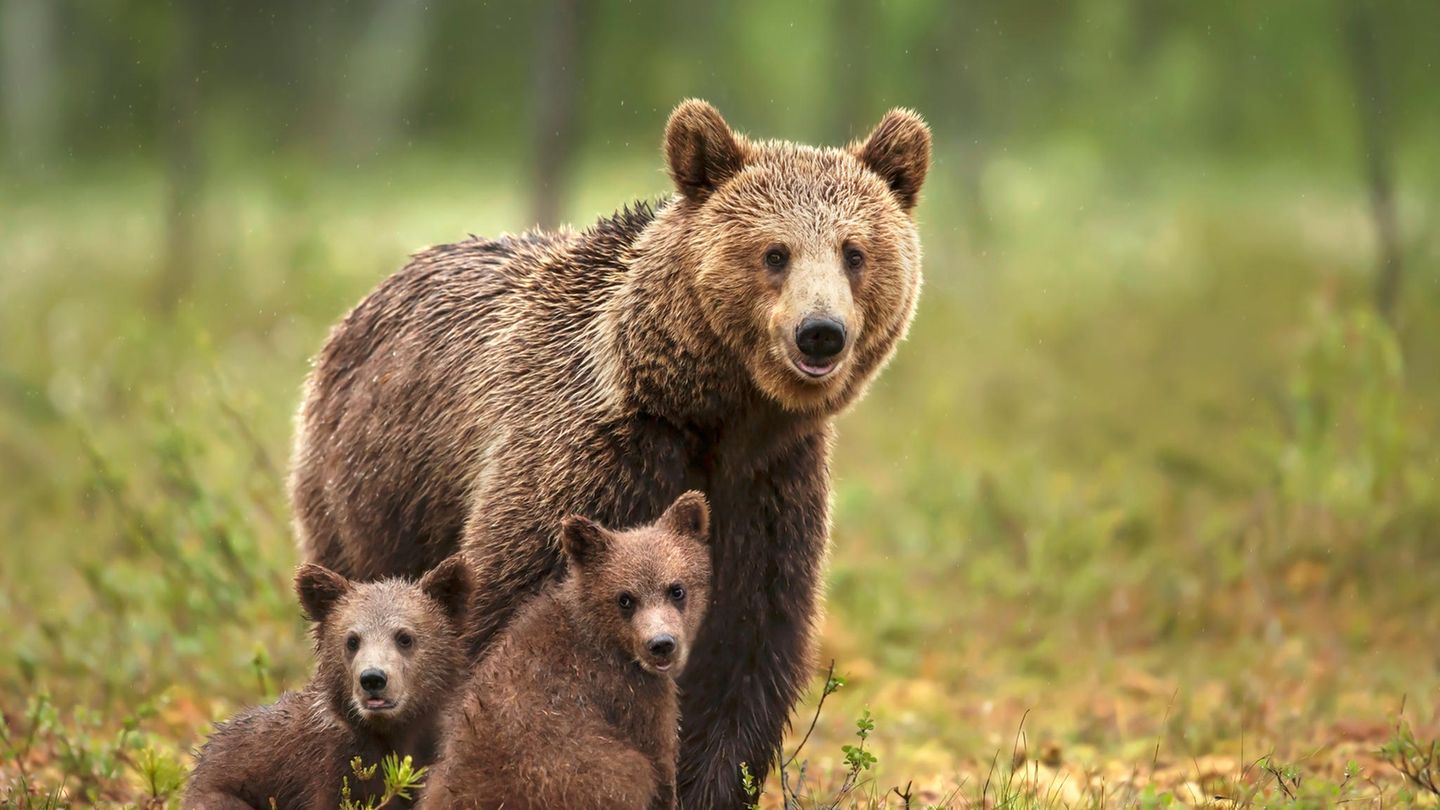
(0, 0, 1440, 807)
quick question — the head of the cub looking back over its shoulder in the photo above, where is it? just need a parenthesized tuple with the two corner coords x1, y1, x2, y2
(562, 491, 710, 677)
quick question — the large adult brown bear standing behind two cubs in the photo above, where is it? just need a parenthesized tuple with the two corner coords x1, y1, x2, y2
(291, 101, 930, 807)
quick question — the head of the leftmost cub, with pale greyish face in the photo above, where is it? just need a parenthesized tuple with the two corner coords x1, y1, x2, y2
(295, 555, 474, 731)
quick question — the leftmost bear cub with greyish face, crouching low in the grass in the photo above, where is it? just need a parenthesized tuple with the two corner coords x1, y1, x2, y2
(184, 555, 472, 809)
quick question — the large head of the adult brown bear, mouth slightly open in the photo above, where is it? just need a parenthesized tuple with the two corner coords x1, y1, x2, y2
(665, 99, 930, 412)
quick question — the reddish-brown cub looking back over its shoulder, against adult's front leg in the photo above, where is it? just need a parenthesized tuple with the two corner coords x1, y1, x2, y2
(422, 491, 710, 810)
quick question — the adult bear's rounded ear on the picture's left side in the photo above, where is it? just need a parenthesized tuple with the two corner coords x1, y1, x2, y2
(665, 98, 746, 202)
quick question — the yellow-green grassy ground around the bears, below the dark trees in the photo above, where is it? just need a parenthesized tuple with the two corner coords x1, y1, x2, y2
(0, 151, 1440, 809)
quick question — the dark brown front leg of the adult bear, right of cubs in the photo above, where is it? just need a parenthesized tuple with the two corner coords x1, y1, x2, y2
(680, 432, 829, 809)
